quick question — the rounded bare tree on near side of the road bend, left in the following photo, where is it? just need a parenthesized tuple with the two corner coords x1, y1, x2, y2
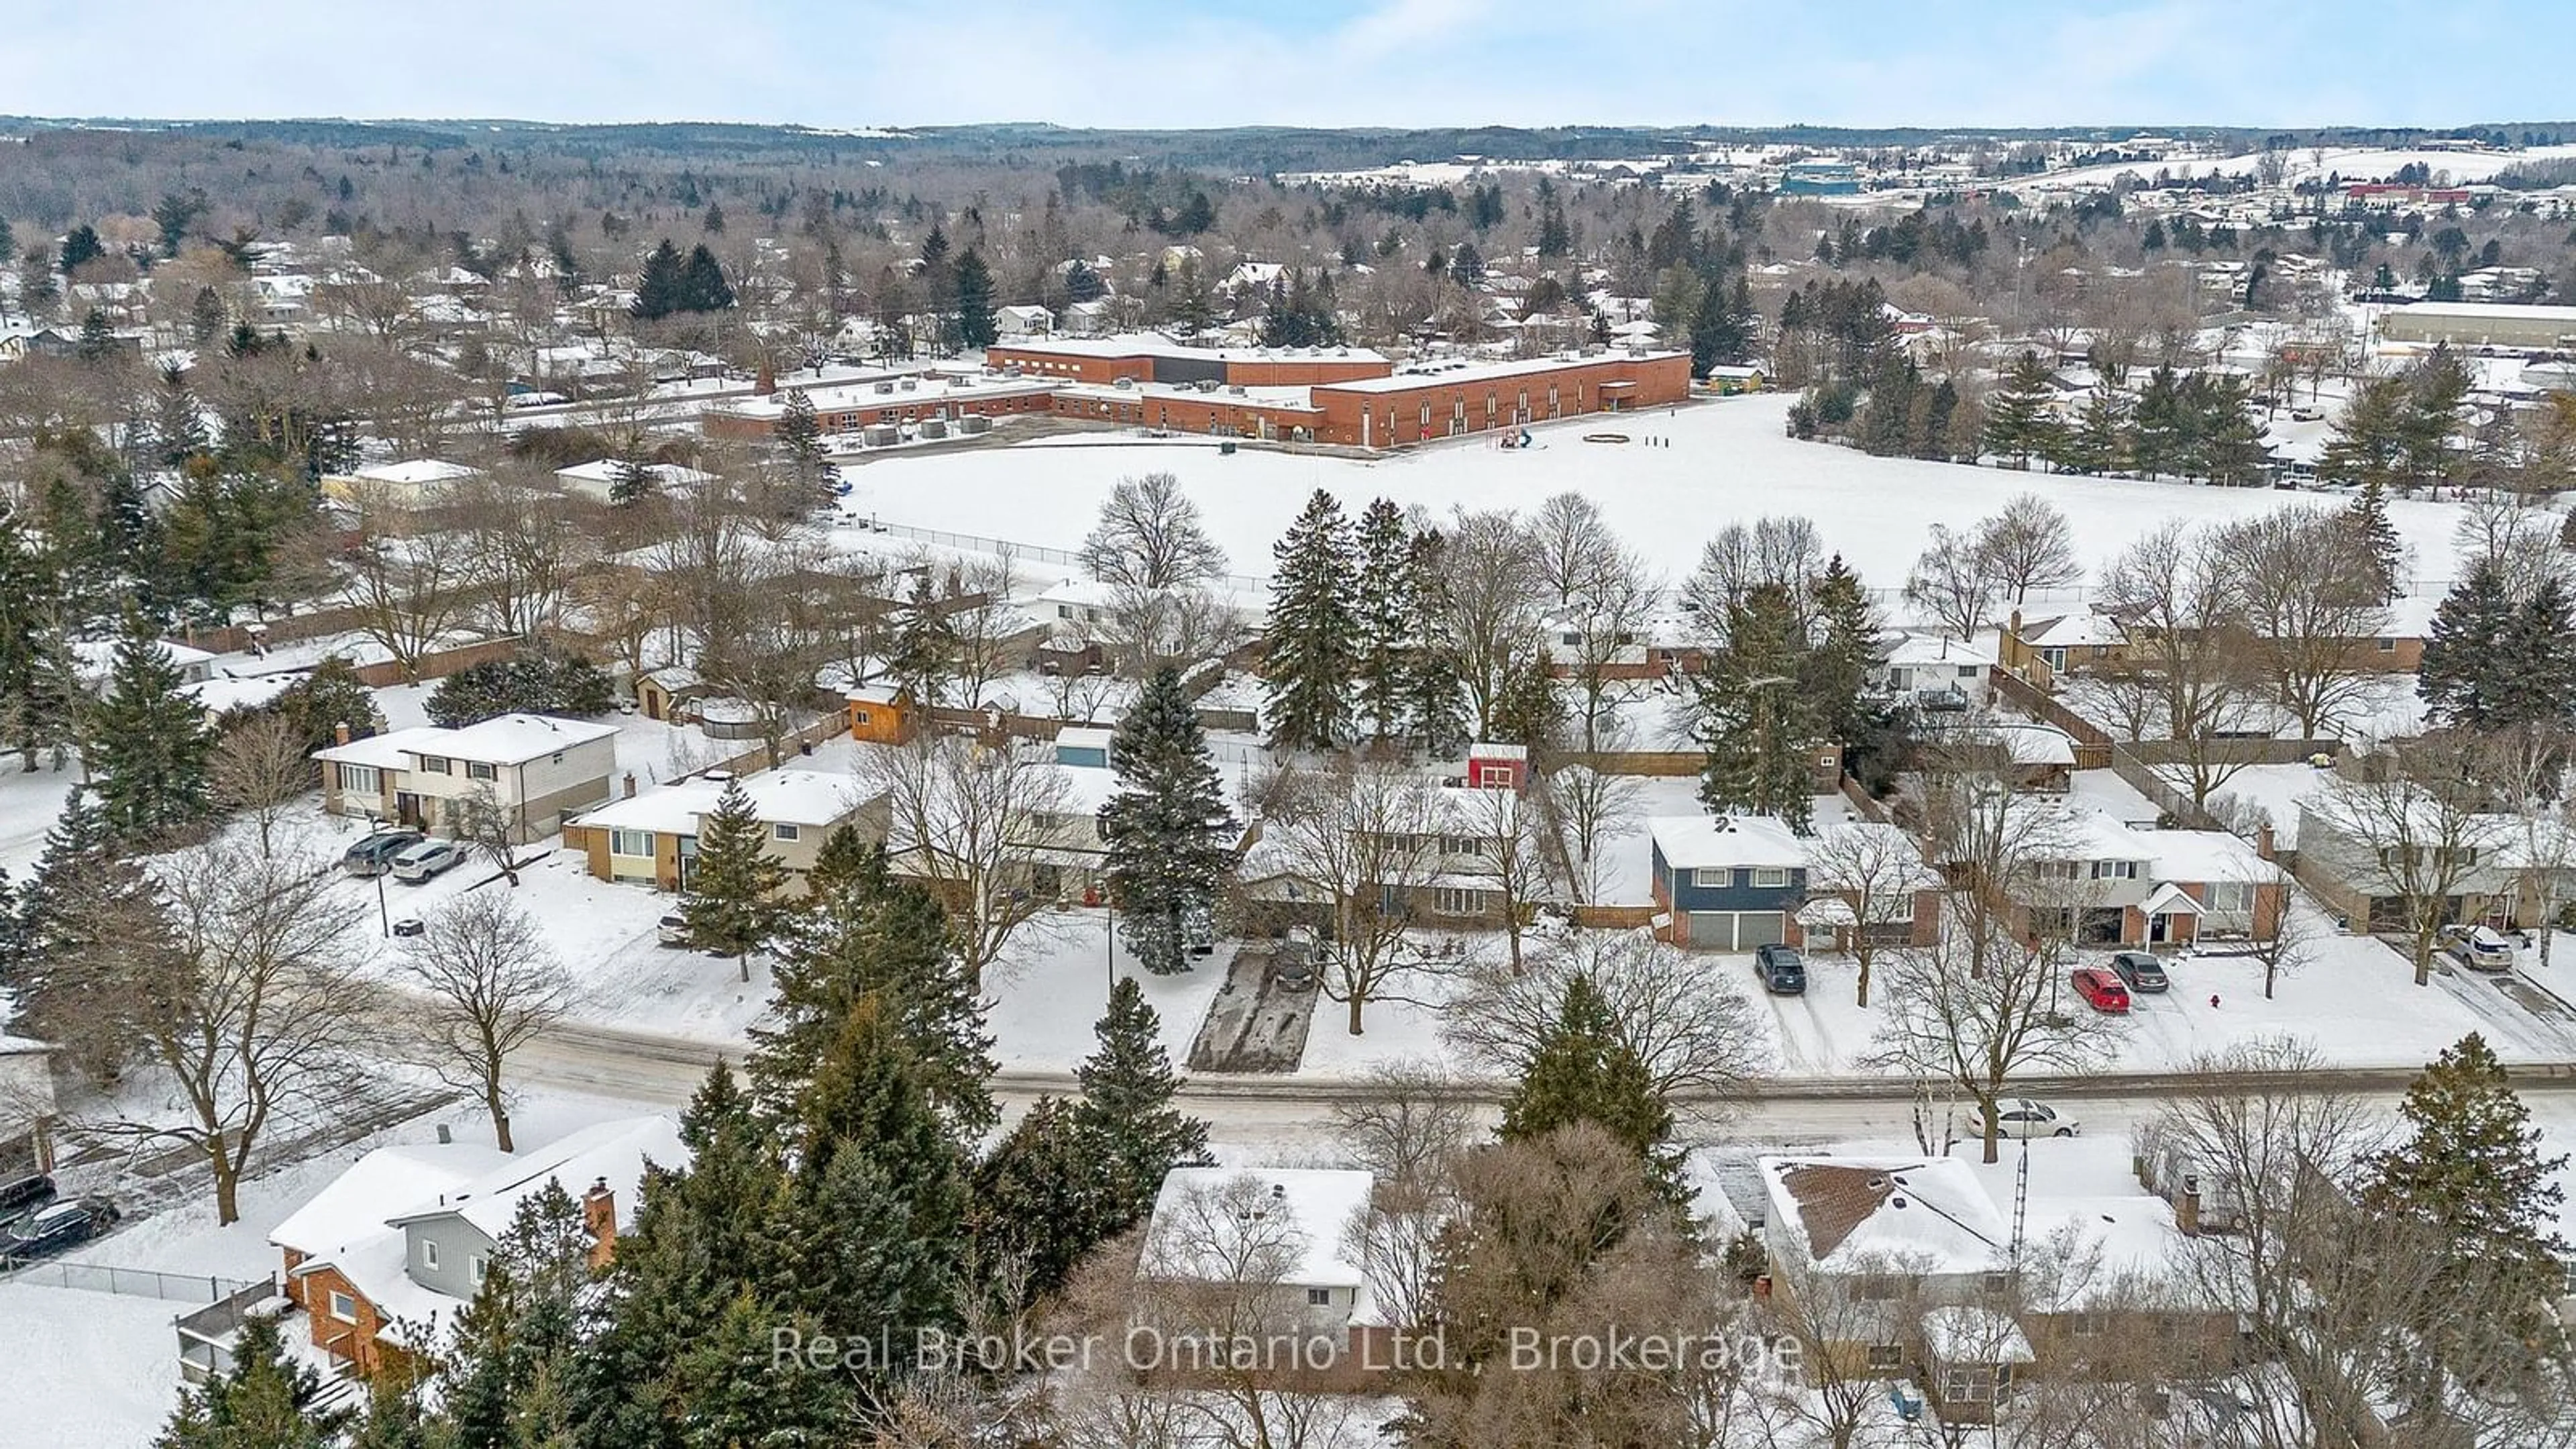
(402, 890, 574, 1152)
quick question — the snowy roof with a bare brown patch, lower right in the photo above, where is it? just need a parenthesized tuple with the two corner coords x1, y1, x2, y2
(1757, 1158, 2012, 1274)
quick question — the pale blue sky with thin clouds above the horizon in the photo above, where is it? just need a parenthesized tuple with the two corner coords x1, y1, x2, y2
(0, 0, 2576, 129)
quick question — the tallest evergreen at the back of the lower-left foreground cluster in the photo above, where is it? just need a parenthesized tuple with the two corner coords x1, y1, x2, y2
(745, 825, 1000, 1142)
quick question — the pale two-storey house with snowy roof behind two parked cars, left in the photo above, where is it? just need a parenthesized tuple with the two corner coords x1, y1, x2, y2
(314, 714, 619, 843)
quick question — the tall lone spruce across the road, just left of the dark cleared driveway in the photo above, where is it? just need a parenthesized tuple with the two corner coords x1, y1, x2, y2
(1100, 667, 1234, 975)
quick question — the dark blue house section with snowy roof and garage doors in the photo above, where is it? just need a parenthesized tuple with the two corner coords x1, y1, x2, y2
(1646, 815, 1806, 951)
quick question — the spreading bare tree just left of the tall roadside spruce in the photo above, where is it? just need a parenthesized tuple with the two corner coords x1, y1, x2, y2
(858, 735, 1085, 982)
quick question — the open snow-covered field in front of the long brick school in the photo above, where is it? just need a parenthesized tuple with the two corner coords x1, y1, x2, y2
(845, 394, 2457, 590)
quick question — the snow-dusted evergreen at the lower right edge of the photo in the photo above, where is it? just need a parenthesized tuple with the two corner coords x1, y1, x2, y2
(2359, 1034, 2568, 1377)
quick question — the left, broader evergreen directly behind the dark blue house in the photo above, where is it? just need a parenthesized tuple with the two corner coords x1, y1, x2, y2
(1695, 583, 1821, 835)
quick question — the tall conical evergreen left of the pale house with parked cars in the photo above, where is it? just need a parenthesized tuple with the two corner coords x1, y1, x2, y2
(83, 614, 214, 841)
